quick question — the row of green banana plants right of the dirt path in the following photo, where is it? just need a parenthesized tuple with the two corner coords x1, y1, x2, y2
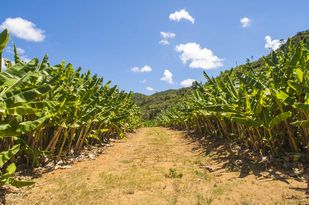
(157, 40, 309, 160)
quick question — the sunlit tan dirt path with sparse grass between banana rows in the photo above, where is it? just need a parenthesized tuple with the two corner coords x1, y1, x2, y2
(7, 128, 308, 205)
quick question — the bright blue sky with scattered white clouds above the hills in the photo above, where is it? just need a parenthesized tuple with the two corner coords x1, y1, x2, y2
(0, 0, 309, 94)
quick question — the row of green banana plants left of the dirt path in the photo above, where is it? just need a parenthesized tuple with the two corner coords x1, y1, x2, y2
(0, 30, 140, 185)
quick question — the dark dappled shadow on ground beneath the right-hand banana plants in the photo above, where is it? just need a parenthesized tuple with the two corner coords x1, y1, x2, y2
(180, 130, 309, 194)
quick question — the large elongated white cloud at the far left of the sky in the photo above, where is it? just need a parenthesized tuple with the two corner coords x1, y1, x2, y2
(0, 17, 45, 42)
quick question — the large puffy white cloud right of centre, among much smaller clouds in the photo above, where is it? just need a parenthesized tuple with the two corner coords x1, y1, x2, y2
(176, 43, 223, 69)
